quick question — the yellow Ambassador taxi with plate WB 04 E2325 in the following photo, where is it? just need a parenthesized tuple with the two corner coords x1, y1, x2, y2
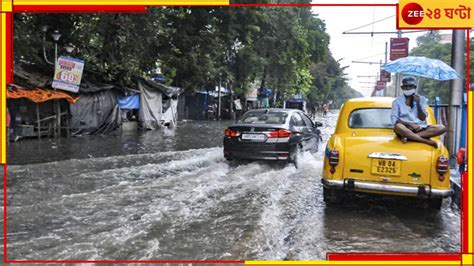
(322, 97, 452, 209)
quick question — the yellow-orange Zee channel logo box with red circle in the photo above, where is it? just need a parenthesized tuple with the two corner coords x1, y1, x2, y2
(397, 0, 474, 29)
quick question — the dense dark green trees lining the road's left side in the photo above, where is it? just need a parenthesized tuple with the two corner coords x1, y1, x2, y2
(14, 6, 360, 108)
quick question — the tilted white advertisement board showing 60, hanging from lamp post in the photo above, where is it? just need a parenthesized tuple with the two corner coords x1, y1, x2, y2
(52, 56, 84, 92)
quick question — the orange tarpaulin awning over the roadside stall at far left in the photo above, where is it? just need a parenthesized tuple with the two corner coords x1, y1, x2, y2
(7, 84, 79, 103)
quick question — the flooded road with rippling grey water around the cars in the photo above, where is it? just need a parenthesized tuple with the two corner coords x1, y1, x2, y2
(2, 112, 460, 260)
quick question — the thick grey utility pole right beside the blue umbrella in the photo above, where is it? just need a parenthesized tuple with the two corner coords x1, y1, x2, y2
(446, 30, 465, 162)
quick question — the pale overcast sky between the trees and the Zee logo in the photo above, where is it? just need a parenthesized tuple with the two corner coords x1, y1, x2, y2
(313, 0, 426, 96)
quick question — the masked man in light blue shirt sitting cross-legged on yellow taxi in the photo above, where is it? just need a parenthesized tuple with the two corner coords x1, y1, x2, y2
(391, 77, 446, 148)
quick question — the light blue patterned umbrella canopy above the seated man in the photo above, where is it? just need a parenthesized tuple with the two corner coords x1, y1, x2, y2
(382, 56, 460, 80)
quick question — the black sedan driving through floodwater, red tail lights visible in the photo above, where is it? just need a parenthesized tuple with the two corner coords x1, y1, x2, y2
(224, 109, 321, 164)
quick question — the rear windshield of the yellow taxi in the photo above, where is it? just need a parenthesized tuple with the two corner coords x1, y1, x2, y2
(349, 108, 393, 128)
